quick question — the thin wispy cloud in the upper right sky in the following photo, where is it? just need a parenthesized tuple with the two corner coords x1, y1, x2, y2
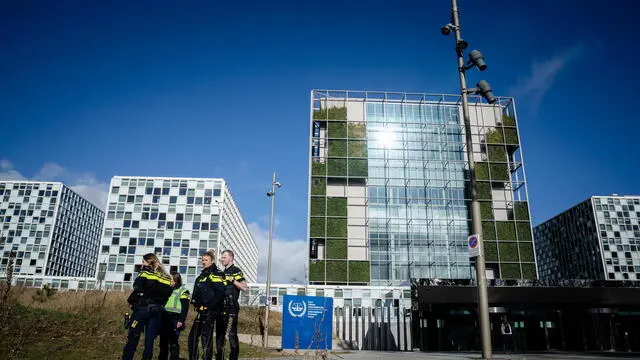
(509, 43, 584, 112)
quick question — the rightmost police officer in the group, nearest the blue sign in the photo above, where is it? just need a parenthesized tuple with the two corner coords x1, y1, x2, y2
(216, 250, 249, 360)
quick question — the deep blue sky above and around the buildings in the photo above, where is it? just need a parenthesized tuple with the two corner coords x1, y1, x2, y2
(0, 0, 640, 282)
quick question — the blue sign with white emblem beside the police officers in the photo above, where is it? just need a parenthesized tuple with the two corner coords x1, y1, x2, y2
(282, 295, 333, 350)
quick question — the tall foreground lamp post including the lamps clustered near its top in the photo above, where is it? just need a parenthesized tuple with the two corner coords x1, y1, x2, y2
(440, 0, 497, 359)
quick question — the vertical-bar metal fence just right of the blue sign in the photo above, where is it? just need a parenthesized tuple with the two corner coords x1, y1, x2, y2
(333, 306, 417, 351)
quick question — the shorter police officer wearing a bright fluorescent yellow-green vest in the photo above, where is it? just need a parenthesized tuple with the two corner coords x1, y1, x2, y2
(158, 271, 189, 360)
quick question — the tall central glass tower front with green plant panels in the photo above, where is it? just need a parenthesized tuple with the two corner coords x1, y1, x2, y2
(309, 90, 537, 286)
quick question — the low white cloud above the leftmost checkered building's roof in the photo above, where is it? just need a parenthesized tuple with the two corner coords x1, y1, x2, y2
(0, 160, 109, 210)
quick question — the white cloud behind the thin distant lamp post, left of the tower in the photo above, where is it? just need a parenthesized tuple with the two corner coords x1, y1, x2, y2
(249, 222, 307, 284)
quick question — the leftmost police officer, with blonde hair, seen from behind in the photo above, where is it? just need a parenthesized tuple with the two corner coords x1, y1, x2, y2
(122, 253, 172, 360)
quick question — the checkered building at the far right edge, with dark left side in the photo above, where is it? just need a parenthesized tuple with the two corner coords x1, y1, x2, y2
(534, 196, 640, 280)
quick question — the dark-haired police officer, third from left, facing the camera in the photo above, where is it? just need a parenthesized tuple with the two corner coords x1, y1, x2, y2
(188, 250, 225, 360)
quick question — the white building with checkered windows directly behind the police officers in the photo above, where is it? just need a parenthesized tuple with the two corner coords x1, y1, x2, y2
(97, 176, 258, 289)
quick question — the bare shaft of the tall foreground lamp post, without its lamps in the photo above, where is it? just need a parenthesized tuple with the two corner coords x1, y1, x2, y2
(451, 0, 492, 359)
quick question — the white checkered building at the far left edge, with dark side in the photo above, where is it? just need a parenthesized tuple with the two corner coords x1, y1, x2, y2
(0, 181, 104, 278)
